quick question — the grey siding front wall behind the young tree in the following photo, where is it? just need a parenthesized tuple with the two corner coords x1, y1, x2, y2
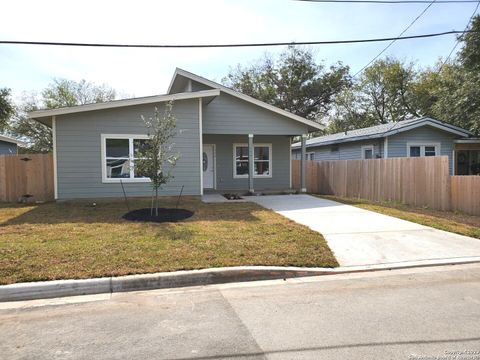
(56, 99, 201, 199)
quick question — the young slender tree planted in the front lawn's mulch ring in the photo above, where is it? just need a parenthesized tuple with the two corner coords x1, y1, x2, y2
(134, 101, 180, 216)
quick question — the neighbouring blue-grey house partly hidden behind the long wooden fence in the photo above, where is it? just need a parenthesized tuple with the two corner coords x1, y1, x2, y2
(292, 117, 480, 175)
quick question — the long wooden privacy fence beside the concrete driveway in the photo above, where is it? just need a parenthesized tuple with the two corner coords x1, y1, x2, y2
(292, 156, 480, 215)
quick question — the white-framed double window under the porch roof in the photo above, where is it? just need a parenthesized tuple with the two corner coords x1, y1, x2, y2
(233, 144, 272, 178)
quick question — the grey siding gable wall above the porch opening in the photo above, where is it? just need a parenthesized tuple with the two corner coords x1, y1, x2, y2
(203, 92, 308, 135)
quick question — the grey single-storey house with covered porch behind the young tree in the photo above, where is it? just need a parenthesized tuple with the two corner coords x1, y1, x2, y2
(29, 69, 322, 199)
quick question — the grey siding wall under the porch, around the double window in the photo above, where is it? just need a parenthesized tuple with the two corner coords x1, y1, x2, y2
(203, 135, 290, 191)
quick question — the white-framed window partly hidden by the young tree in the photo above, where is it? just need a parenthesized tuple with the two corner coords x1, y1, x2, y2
(102, 135, 150, 182)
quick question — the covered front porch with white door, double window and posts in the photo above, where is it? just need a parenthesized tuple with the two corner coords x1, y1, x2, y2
(202, 134, 305, 193)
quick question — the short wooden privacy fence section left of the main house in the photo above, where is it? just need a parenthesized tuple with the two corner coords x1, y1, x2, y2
(0, 154, 54, 202)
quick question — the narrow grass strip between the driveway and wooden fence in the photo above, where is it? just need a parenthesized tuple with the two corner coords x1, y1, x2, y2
(321, 195, 480, 239)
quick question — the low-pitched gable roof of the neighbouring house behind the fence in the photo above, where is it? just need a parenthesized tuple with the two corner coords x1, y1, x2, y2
(292, 117, 473, 148)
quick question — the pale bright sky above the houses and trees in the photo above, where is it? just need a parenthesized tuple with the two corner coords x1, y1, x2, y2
(0, 0, 476, 97)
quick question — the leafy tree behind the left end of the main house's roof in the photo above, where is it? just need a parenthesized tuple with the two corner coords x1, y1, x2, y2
(12, 79, 116, 152)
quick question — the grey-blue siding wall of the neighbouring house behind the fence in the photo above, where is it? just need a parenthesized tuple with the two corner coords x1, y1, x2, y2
(292, 139, 383, 161)
